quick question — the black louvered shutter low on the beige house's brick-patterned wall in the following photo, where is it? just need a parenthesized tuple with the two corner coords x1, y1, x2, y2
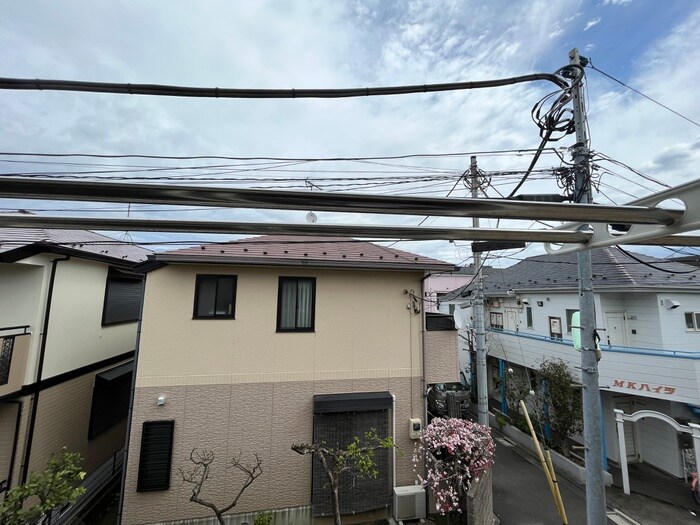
(136, 421, 175, 492)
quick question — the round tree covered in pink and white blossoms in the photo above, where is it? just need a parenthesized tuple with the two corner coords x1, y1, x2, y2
(413, 418, 496, 514)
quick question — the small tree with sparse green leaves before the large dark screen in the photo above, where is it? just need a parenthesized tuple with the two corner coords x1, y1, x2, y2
(292, 429, 396, 525)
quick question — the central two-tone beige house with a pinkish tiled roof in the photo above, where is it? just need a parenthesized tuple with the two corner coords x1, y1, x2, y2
(121, 236, 458, 524)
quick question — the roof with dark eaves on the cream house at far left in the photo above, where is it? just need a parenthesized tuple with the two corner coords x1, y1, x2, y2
(0, 228, 152, 266)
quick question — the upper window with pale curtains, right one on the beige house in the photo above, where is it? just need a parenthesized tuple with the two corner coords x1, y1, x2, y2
(277, 277, 316, 332)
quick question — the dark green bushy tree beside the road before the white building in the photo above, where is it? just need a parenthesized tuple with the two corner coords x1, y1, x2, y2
(536, 359, 583, 453)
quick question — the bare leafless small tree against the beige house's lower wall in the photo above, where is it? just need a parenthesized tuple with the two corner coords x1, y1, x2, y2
(178, 448, 262, 525)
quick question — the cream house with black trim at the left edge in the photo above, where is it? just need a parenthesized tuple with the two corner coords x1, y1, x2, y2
(0, 223, 150, 499)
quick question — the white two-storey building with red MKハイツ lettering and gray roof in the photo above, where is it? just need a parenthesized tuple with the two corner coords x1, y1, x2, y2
(448, 248, 700, 477)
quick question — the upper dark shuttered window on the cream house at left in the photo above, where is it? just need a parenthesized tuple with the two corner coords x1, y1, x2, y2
(102, 268, 143, 326)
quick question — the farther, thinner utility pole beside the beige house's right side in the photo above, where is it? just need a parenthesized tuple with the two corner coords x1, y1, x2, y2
(469, 155, 489, 426)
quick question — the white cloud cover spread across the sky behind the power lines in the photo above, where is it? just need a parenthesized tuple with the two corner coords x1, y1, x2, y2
(0, 0, 700, 260)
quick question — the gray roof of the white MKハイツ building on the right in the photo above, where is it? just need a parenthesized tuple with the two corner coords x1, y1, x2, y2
(443, 247, 700, 300)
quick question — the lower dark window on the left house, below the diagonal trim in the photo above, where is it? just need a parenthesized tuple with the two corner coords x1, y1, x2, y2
(88, 361, 134, 439)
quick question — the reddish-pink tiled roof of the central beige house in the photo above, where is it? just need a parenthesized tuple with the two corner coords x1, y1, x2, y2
(154, 235, 454, 270)
